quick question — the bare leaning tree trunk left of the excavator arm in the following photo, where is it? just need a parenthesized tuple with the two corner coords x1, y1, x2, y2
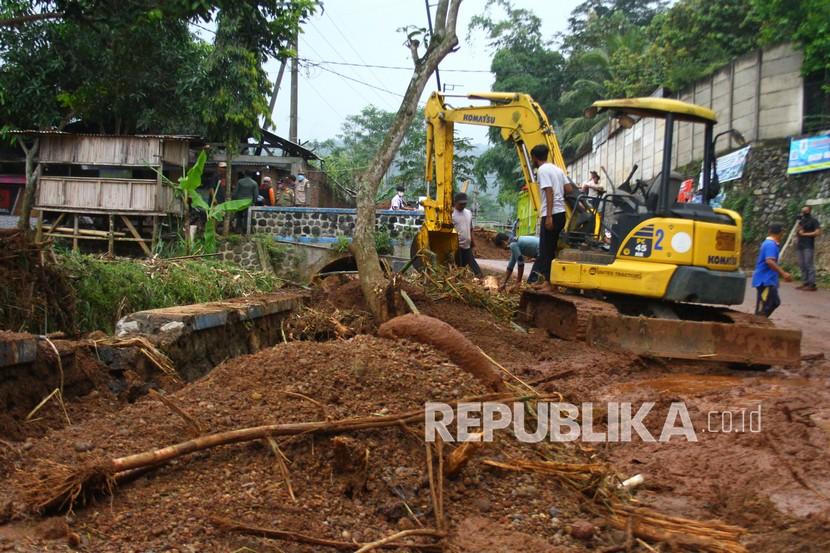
(351, 0, 461, 322)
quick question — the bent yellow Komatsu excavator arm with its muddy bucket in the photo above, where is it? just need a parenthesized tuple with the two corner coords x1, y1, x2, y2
(420, 92, 566, 264)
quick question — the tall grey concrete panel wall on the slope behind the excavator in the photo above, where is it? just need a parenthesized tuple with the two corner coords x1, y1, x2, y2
(568, 44, 804, 184)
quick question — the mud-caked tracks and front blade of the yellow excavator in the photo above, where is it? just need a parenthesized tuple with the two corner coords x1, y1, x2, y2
(519, 290, 801, 366)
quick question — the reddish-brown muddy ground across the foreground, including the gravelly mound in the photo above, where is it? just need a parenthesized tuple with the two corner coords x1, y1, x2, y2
(0, 274, 830, 553)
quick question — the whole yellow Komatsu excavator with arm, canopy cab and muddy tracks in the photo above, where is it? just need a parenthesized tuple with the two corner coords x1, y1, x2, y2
(420, 92, 801, 365)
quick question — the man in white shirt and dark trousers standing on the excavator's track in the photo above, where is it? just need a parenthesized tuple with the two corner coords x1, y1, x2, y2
(530, 144, 573, 290)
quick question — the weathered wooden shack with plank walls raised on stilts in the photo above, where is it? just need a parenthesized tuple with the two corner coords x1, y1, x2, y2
(22, 131, 198, 256)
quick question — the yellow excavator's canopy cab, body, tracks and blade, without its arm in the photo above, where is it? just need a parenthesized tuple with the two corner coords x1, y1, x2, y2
(520, 98, 801, 365)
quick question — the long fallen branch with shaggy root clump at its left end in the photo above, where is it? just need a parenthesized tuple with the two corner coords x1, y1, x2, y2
(17, 394, 545, 512)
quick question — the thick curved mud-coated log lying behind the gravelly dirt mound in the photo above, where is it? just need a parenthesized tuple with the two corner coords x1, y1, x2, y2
(378, 313, 506, 392)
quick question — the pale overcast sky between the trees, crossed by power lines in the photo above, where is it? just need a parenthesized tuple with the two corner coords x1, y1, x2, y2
(266, 0, 582, 144)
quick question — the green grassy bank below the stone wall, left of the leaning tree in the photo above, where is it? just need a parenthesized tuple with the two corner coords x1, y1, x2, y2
(58, 254, 279, 332)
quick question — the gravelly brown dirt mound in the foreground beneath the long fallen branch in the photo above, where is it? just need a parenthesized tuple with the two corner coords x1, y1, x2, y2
(0, 336, 616, 553)
